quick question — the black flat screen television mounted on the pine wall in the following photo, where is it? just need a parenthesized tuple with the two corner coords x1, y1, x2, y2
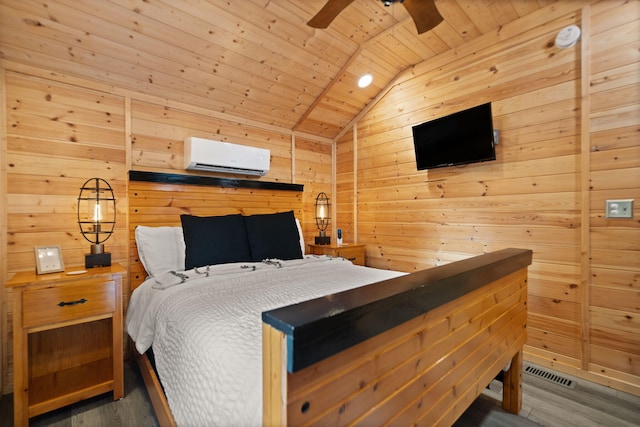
(413, 103, 496, 170)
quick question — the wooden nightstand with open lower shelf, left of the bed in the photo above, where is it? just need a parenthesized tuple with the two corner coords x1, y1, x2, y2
(7, 264, 126, 426)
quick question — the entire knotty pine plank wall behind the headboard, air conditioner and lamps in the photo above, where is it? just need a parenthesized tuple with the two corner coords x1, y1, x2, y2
(0, 66, 333, 393)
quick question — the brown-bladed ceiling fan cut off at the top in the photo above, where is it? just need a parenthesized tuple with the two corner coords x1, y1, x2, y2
(307, 0, 442, 34)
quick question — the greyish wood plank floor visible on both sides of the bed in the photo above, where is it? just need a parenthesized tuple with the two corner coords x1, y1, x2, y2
(0, 364, 640, 427)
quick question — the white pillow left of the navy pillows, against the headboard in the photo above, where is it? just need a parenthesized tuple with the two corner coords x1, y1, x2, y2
(136, 225, 185, 277)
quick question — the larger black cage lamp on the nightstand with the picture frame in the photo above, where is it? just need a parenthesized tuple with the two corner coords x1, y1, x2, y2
(78, 178, 116, 268)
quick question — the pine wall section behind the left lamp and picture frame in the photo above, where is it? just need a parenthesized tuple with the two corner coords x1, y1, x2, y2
(2, 70, 127, 392)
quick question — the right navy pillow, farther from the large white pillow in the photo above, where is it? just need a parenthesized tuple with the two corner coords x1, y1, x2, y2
(244, 211, 302, 261)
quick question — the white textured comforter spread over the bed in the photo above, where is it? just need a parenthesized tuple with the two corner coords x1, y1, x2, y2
(126, 256, 402, 426)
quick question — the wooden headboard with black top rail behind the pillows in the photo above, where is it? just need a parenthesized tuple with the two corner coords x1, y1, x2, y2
(129, 171, 304, 290)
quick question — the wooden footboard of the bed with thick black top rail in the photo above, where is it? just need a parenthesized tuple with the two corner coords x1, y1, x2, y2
(263, 249, 532, 426)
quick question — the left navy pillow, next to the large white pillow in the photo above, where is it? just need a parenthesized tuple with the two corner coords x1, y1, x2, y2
(180, 214, 251, 270)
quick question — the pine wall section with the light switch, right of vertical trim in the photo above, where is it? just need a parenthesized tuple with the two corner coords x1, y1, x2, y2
(585, 2, 640, 388)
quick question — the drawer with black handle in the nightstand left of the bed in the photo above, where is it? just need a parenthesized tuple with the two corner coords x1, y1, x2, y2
(22, 280, 115, 328)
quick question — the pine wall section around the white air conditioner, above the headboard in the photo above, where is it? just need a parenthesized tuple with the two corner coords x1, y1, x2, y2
(131, 100, 332, 234)
